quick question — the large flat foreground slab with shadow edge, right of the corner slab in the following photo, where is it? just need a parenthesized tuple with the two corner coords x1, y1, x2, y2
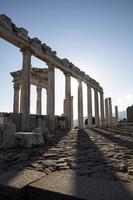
(28, 170, 133, 200)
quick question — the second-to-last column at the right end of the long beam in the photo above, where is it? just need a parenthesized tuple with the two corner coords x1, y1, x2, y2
(94, 89, 99, 127)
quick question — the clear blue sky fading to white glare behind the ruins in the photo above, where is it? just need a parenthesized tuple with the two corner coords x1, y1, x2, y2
(0, 0, 133, 119)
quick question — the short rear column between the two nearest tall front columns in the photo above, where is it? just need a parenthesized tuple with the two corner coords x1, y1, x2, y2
(36, 86, 42, 115)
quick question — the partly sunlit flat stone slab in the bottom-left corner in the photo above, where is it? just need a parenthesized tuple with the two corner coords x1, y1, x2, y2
(0, 169, 46, 200)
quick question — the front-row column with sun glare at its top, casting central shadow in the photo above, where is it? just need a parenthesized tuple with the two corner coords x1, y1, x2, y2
(78, 80, 83, 129)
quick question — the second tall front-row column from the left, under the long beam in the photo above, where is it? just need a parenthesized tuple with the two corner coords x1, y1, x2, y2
(47, 63, 55, 116)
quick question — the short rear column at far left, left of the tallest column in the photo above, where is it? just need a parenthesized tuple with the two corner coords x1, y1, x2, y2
(13, 83, 20, 113)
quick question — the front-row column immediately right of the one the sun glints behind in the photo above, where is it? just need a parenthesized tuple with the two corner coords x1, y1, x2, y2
(87, 85, 92, 128)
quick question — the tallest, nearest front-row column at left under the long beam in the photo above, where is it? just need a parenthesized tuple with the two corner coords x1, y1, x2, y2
(20, 49, 31, 114)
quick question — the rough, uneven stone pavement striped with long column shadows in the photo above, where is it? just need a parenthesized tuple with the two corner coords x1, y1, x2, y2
(0, 128, 133, 199)
